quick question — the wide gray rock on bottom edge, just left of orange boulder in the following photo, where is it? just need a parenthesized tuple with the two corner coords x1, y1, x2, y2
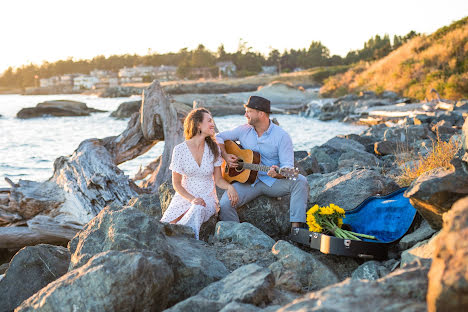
(278, 267, 428, 312)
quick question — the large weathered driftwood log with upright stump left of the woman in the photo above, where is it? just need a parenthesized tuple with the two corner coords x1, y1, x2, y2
(0, 81, 190, 248)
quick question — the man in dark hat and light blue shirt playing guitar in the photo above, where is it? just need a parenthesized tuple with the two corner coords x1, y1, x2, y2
(216, 96, 309, 227)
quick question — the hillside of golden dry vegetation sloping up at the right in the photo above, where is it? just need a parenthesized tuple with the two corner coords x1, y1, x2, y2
(320, 17, 468, 100)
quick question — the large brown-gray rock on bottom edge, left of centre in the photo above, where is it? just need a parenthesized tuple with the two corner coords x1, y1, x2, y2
(16, 251, 174, 311)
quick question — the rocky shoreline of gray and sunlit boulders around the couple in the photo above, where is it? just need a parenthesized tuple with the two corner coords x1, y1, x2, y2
(0, 82, 468, 312)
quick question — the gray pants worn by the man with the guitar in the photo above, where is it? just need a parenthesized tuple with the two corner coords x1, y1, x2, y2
(219, 175, 309, 223)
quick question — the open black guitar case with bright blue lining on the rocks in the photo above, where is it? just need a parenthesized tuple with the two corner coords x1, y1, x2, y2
(290, 188, 416, 260)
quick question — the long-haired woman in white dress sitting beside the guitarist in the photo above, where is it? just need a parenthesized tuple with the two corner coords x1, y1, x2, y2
(161, 108, 238, 239)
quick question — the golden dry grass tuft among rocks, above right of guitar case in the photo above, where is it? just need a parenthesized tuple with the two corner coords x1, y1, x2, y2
(396, 136, 460, 187)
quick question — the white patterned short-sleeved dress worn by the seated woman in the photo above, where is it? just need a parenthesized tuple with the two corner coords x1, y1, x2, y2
(161, 141, 222, 239)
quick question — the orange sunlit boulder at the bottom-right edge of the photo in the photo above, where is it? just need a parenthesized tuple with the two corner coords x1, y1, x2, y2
(427, 197, 468, 312)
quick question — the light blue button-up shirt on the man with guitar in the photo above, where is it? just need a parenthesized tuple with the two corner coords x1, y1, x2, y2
(216, 120, 294, 186)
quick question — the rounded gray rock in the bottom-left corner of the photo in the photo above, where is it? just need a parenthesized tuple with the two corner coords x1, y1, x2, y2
(0, 244, 70, 311)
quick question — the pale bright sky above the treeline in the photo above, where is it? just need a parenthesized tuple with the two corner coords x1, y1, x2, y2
(0, 0, 468, 72)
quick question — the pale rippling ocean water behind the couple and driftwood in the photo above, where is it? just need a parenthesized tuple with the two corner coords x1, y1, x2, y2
(0, 94, 367, 187)
